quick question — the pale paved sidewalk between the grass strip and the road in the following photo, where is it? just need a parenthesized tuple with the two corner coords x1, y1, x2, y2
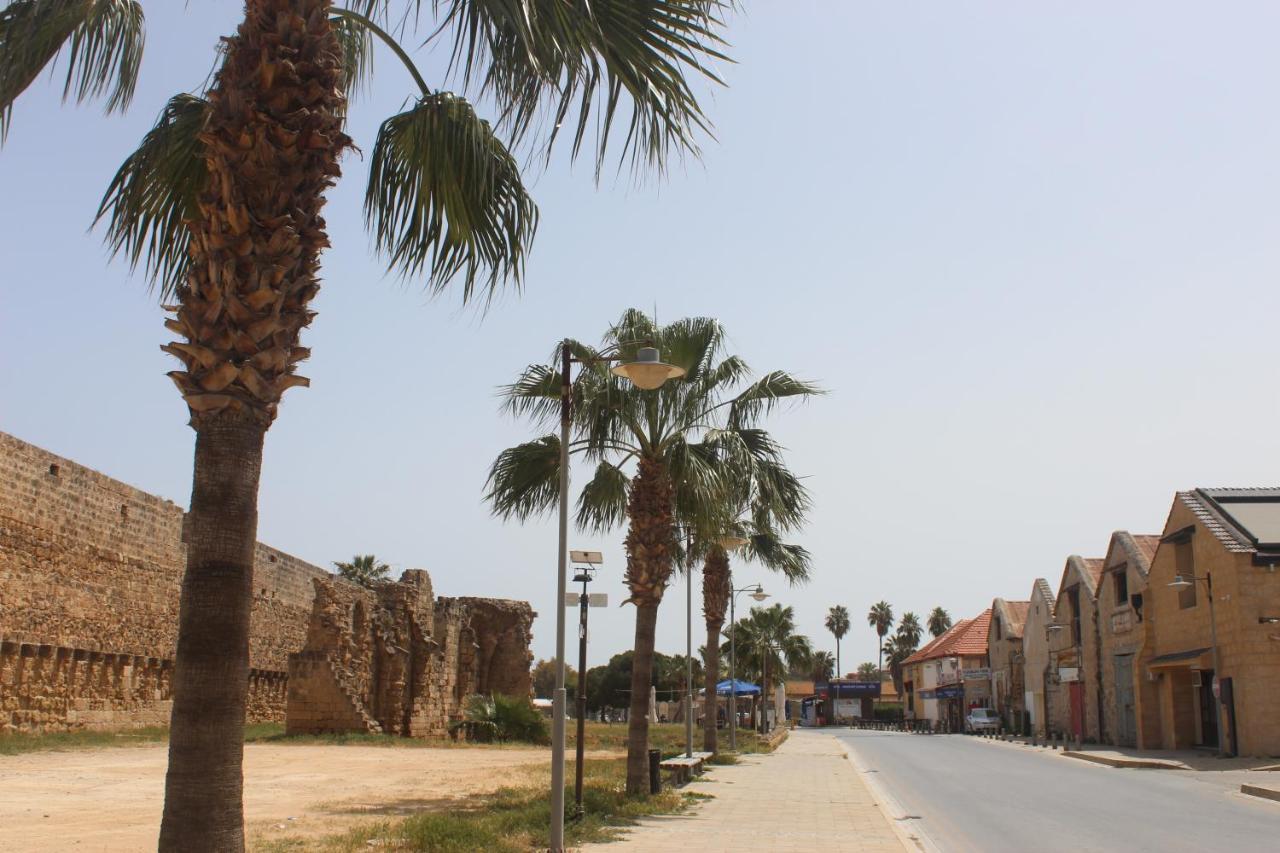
(582, 730, 904, 853)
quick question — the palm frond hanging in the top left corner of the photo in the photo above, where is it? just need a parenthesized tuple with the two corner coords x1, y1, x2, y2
(0, 0, 146, 141)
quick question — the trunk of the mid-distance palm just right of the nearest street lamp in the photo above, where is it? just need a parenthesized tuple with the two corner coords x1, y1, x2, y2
(626, 456, 675, 794)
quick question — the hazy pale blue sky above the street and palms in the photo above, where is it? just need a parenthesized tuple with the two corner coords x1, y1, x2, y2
(0, 0, 1280, 671)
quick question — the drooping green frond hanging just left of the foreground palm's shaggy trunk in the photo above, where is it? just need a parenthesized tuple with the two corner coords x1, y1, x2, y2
(93, 95, 209, 296)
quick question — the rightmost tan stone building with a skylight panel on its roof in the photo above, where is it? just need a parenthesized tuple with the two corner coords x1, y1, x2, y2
(1135, 488, 1280, 756)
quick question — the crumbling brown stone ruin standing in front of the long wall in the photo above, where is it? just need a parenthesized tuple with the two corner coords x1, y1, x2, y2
(285, 570, 535, 738)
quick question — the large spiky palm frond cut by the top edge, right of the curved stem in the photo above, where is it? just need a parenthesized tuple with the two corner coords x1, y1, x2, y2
(436, 0, 728, 177)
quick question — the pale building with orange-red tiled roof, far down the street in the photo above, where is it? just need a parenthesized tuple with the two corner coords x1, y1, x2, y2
(902, 610, 991, 731)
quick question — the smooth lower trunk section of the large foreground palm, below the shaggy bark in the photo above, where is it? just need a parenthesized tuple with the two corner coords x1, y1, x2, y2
(160, 416, 266, 852)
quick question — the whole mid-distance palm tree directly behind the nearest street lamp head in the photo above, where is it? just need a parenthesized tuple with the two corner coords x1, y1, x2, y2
(485, 310, 817, 794)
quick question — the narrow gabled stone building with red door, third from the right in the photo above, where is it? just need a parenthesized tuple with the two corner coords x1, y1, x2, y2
(1044, 555, 1102, 742)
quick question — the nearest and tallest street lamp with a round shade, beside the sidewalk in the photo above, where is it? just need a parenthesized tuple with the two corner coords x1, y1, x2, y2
(550, 339, 685, 853)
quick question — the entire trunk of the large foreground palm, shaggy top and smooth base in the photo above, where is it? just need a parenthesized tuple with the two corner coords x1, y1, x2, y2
(160, 0, 349, 852)
